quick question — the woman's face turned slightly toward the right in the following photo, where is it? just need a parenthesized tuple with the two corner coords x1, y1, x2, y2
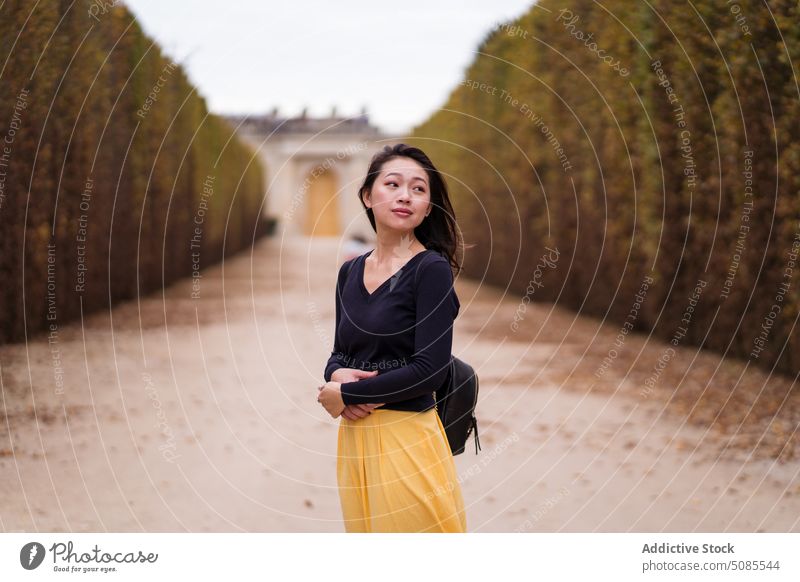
(364, 158, 431, 231)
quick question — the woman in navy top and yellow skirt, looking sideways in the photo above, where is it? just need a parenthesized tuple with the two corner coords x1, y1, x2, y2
(317, 144, 467, 532)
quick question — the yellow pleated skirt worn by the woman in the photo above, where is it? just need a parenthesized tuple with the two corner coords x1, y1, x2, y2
(336, 408, 467, 533)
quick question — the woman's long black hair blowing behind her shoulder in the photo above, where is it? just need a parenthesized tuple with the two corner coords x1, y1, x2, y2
(358, 143, 462, 275)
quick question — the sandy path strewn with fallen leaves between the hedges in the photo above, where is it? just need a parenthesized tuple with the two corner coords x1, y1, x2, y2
(0, 238, 800, 531)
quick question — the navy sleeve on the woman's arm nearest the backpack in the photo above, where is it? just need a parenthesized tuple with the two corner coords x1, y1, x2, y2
(341, 260, 460, 405)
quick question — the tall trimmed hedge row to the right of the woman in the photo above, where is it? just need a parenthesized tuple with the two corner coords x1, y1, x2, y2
(413, 0, 800, 374)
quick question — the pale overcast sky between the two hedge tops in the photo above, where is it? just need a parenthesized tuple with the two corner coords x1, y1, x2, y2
(126, 0, 534, 132)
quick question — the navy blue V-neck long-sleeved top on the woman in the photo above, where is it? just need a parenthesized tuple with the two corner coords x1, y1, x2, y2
(324, 249, 461, 412)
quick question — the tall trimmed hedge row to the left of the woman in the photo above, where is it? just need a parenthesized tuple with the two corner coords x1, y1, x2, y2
(0, 0, 264, 341)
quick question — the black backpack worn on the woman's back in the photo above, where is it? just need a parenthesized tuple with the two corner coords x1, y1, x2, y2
(345, 260, 481, 456)
